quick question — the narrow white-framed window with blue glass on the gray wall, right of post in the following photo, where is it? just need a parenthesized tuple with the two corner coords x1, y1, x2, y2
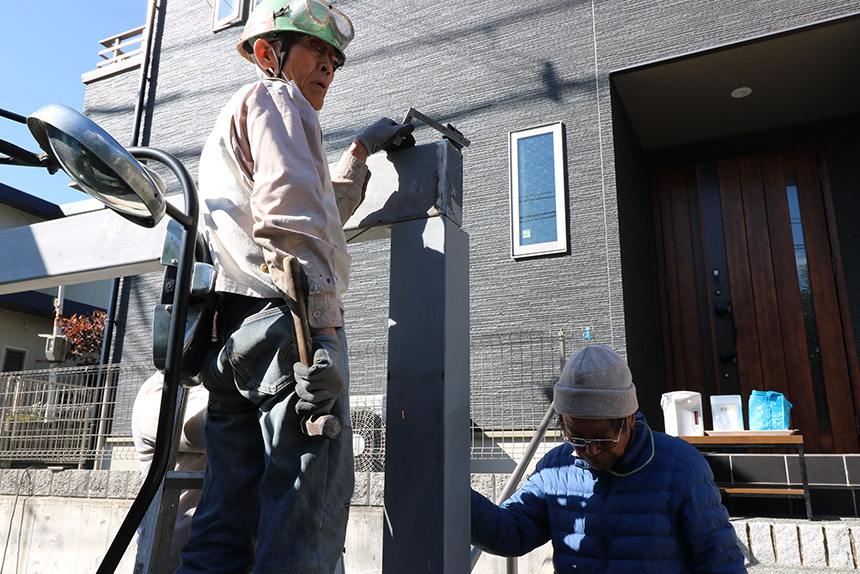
(509, 122, 567, 257)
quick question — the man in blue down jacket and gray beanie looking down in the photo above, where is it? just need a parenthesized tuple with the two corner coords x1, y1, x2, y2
(472, 345, 746, 574)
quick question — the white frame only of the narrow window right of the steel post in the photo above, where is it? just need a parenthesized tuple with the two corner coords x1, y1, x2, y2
(508, 122, 568, 259)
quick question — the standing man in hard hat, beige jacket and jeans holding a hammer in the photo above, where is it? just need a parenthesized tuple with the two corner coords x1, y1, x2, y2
(177, 0, 414, 574)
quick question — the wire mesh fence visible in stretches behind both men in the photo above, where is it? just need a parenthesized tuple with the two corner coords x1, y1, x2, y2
(0, 331, 583, 472)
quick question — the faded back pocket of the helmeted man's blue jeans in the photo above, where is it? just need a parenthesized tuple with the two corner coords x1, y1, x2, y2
(225, 305, 299, 410)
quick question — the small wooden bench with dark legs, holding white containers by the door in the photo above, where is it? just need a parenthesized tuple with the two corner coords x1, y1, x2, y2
(679, 430, 812, 519)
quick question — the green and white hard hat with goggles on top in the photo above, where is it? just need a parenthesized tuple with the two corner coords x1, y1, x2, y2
(236, 0, 355, 63)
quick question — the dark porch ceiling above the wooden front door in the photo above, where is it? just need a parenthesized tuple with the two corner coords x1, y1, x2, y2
(610, 14, 860, 151)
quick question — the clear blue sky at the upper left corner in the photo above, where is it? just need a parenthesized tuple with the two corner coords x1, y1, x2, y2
(0, 0, 149, 204)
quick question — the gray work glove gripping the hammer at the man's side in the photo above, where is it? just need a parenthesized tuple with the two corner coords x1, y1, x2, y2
(293, 335, 345, 417)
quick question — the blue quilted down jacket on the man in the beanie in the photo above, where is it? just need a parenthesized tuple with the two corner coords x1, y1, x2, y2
(472, 413, 746, 574)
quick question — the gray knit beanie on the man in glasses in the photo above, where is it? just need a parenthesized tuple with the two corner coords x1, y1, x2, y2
(552, 345, 639, 419)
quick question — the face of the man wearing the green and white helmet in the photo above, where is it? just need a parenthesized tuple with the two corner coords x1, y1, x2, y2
(281, 36, 339, 111)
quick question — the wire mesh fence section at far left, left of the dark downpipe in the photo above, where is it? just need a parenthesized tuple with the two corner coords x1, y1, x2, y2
(0, 364, 149, 466)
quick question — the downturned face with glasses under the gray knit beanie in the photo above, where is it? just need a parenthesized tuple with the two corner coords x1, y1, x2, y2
(562, 415, 634, 470)
